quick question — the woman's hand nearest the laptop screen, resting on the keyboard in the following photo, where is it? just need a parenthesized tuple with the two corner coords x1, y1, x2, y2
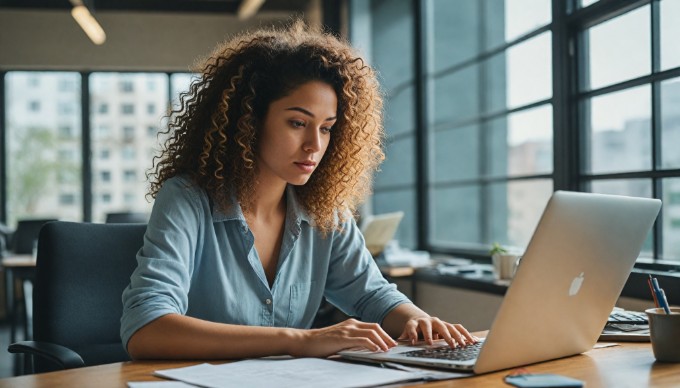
(398, 316, 479, 348)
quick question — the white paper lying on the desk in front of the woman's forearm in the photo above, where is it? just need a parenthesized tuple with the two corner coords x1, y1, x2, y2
(154, 358, 420, 388)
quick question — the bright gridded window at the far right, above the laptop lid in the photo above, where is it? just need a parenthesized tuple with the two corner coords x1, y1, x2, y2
(574, 0, 680, 262)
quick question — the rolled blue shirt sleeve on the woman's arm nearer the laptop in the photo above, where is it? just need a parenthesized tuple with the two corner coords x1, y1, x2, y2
(325, 219, 410, 323)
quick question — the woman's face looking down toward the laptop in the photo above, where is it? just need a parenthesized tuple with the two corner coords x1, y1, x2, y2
(257, 81, 338, 186)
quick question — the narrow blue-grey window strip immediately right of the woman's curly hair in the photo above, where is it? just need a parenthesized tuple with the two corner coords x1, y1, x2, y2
(356, 1, 418, 248)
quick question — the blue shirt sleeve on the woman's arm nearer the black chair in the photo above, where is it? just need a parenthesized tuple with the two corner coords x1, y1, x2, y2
(120, 178, 204, 348)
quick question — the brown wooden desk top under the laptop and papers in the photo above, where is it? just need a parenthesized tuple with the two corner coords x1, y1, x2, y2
(0, 343, 680, 388)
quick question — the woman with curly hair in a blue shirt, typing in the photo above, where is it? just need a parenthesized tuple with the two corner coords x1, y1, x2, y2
(121, 23, 476, 359)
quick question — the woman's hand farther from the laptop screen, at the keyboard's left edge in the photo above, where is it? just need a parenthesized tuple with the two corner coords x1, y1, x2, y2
(291, 319, 397, 357)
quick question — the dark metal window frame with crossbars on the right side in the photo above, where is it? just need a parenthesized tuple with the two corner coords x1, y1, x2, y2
(350, 0, 680, 276)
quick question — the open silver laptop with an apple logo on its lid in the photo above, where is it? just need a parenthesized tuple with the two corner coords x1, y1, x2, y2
(340, 191, 661, 373)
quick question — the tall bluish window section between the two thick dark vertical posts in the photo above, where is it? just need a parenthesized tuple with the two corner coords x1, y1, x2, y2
(428, 0, 553, 249)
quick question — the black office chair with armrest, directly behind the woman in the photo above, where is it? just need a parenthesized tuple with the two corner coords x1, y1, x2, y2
(8, 222, 146, 372)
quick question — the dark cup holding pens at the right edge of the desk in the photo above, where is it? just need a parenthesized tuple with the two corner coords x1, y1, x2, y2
(645, 307, 680, 362)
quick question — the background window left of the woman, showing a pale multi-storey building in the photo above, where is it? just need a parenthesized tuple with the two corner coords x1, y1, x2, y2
(3, 71, 191, 226)
